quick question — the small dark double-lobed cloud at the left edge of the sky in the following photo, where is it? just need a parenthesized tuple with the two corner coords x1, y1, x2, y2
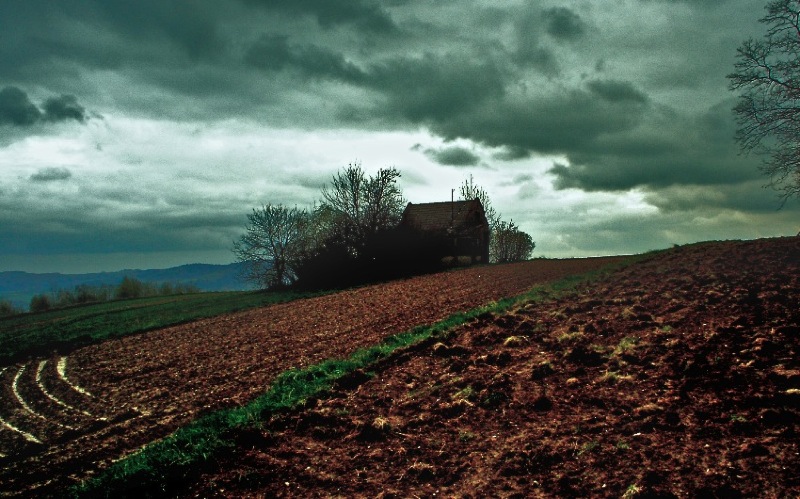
(0, 86, 87, 127)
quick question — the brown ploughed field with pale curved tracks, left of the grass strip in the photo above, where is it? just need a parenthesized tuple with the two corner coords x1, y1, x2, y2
(0, 258, 620, 496)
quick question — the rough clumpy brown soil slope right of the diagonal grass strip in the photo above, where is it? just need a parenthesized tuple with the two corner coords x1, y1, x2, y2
(185, 238, 800, 498)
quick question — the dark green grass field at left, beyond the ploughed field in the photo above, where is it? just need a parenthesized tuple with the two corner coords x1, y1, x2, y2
(0, 291, 318, 364)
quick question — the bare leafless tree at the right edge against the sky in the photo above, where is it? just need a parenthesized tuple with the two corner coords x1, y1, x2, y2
(728, 0, 800, 203)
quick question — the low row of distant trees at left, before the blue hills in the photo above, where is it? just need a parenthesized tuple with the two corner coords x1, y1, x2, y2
(0, 276, 200, 317)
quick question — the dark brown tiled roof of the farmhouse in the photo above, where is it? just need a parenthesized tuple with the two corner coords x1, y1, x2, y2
(403, 199, 488, 231)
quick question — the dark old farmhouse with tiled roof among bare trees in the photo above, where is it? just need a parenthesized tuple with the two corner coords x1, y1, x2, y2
(400, 199, 489, 263)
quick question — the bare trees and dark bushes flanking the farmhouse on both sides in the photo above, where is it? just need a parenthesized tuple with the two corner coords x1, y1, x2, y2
(233, 163, 535, 289)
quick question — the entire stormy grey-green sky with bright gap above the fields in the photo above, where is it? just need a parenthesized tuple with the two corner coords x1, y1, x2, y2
(0, 0, 800, 272)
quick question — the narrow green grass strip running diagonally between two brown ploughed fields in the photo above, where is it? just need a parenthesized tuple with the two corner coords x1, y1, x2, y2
(70, 259, 635, 497)
